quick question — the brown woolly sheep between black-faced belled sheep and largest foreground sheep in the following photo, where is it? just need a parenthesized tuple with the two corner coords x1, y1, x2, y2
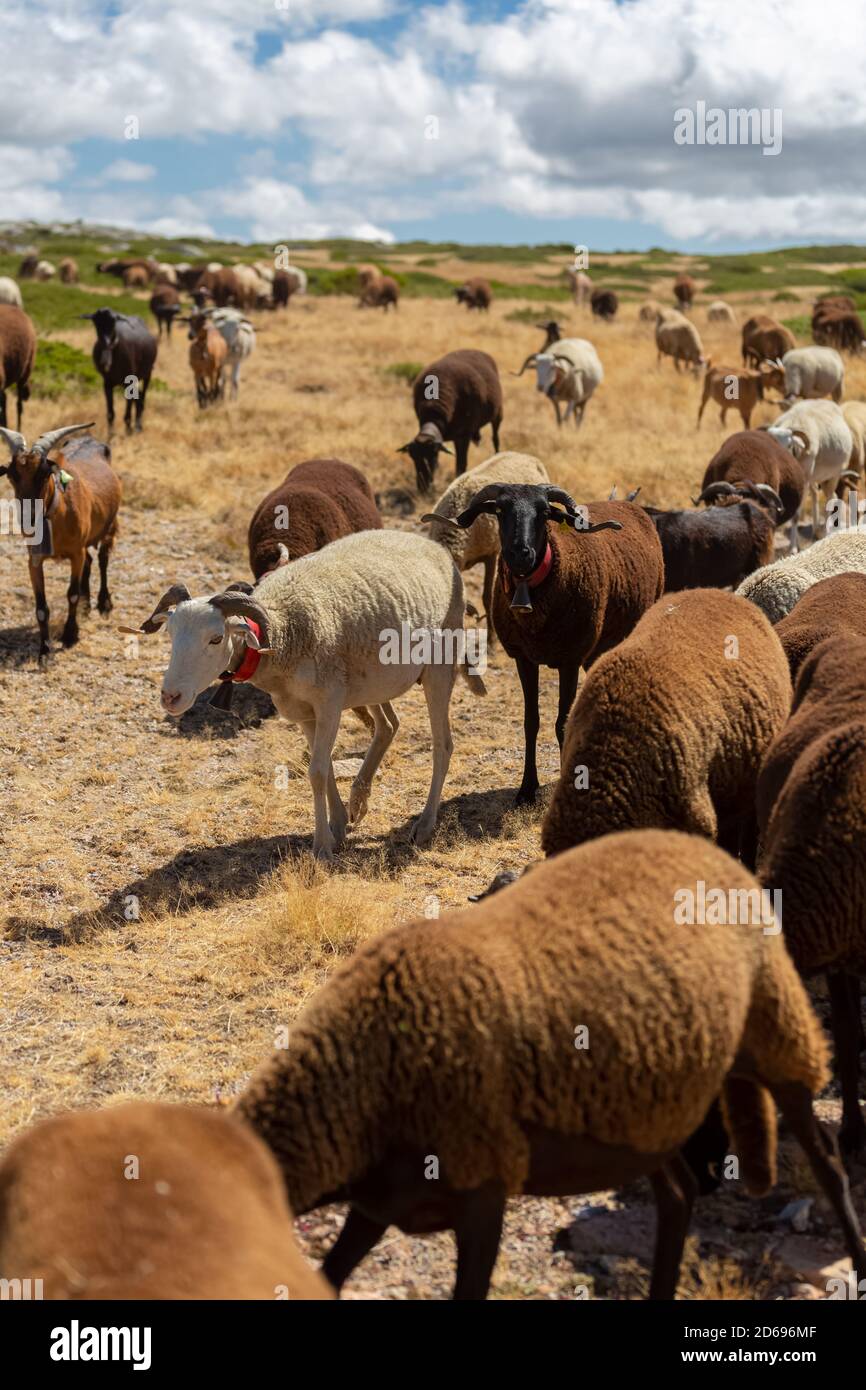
(541, 589, 791, 855)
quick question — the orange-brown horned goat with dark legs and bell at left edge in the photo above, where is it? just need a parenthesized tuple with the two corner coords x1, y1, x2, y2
(0, 425, 121, 662)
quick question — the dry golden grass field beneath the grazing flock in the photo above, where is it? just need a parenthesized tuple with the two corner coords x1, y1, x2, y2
(0, 257, 866, 1298)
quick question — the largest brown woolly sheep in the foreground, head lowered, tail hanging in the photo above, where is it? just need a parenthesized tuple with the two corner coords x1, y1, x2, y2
(235, 830, 866, 1300)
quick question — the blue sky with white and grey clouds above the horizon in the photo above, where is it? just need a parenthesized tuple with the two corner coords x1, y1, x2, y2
(0, 0, 866, 253)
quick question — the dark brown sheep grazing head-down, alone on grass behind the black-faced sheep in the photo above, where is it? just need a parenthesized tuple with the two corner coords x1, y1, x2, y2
(398, 348, 502, 493)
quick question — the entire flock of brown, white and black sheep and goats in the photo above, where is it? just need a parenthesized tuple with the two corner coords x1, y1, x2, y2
(0, 257, 866, 1300)
